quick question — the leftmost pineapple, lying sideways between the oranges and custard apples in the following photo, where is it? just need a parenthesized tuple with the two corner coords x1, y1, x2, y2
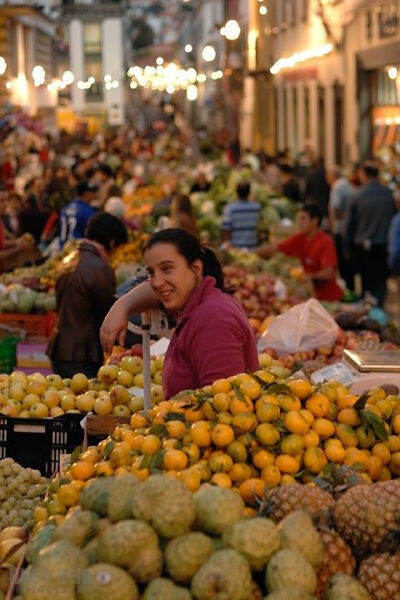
(261, 484, 335, 522)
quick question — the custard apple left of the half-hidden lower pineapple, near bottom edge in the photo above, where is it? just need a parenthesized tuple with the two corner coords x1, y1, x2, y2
(265, 549, 317, 594)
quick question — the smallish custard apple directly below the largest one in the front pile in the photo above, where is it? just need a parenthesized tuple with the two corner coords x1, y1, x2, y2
(165, 532, 214, 583)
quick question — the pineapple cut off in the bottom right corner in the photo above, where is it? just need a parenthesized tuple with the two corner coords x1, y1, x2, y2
(358, 552, 400, 600)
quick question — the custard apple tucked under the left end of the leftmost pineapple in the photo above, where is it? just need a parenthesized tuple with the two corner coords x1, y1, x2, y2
(222, 517, 280, 571)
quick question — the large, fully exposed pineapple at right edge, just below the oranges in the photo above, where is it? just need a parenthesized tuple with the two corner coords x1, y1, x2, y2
(334, 480, 400, 556)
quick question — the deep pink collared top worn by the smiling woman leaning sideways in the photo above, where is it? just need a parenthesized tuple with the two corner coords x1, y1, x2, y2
(163, 277, 259, 399)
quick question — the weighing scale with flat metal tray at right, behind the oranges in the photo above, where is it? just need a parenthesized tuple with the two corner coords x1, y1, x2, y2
(311, 350, 400, 394)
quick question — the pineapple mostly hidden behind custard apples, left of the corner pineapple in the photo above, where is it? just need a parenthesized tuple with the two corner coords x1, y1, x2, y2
(317, 530, 356, 598)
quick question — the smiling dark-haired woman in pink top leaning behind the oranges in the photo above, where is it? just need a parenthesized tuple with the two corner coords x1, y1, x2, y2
(100, 229, 258, 398)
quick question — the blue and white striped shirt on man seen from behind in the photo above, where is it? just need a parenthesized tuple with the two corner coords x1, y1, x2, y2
(221, 200, 261, 248)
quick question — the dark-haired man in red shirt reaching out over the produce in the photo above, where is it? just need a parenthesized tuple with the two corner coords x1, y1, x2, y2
(257, 204, 343, 302)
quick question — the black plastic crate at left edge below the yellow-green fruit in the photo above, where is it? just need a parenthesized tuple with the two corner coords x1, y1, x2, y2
(0, 414, 83, 477)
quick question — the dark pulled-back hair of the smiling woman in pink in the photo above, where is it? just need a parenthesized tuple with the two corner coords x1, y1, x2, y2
(144, 228, 232, 294)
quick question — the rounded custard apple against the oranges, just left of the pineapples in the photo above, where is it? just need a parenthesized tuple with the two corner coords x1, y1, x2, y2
(194, 486, 244, 535)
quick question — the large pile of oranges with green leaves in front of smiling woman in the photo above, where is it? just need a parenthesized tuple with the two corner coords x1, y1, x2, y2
(38, 355, 400, 514)
